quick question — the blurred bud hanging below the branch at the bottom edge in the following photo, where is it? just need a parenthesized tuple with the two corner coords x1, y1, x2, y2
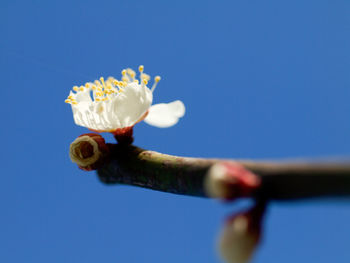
(218, 204, 265, 263)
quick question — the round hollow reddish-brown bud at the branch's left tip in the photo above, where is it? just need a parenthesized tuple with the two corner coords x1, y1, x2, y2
(69, 133, 109, 171)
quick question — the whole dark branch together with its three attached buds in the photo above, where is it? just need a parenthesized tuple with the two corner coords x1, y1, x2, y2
(69, 136, 350, 262)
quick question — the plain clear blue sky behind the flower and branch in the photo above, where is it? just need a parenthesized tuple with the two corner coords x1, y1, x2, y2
(0, 0, 350, 263)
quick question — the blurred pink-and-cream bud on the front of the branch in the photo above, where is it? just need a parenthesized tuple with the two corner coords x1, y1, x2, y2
(204, 162, 261, 200)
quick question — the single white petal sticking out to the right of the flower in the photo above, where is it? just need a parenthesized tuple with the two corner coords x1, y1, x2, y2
(145, 100, 185, 128)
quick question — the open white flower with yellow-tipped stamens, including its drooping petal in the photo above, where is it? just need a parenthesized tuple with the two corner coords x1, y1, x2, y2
(65, 66, 185, 132)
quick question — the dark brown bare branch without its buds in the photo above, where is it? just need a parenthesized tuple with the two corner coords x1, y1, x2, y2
(98, 144, 350, 200)
